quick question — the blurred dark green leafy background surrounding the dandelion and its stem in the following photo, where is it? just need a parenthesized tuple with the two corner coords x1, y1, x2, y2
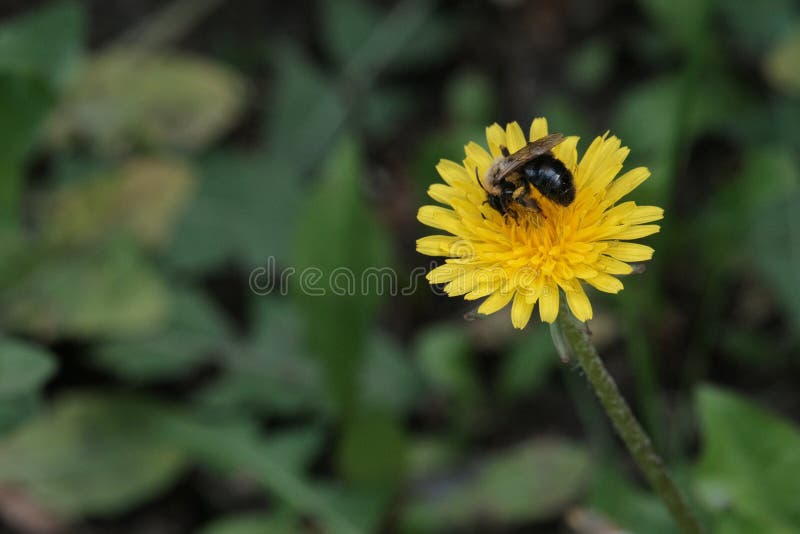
(0, 0, 800, 534)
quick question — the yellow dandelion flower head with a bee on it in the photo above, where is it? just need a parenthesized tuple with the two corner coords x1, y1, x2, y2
(417, 118, 664, 328)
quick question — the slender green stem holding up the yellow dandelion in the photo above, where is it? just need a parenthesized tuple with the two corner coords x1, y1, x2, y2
(557, 306, 703, 534)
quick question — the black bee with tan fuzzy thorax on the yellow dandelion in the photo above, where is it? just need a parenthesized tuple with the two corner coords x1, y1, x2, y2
(475, 134, 575, 216)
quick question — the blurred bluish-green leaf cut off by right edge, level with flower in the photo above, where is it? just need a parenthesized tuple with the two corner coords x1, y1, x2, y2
(748, 187, 800, 332)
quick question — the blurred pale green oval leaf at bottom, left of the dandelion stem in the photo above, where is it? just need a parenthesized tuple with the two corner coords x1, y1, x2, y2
(403, 439, 589, 532)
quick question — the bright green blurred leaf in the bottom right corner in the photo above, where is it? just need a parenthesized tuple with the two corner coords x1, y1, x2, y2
(697, 386, 800, 533)
